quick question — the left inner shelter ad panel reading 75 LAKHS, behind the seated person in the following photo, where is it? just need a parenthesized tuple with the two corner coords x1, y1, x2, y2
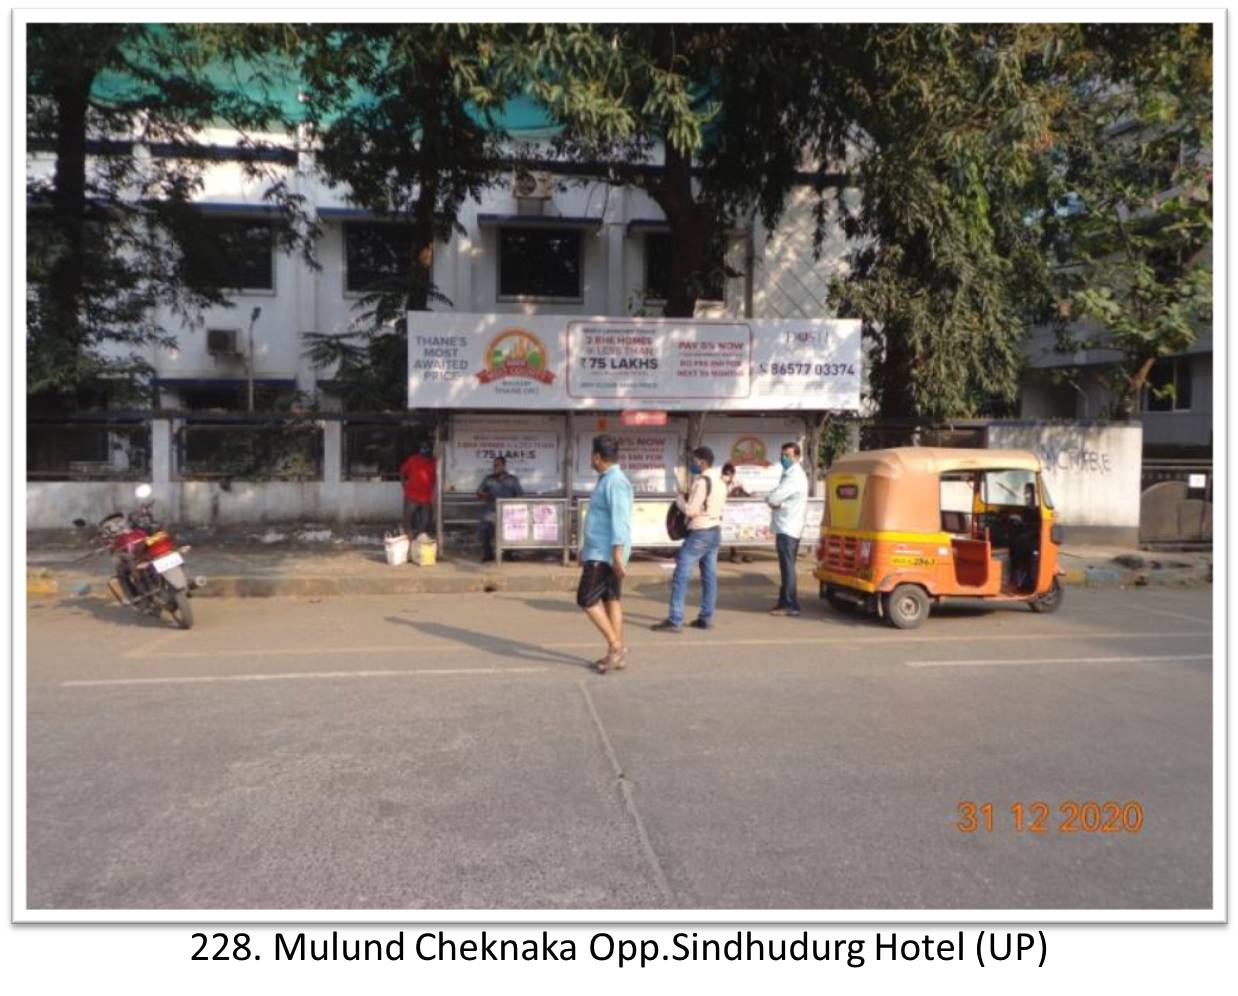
(446, 416, 563, 494)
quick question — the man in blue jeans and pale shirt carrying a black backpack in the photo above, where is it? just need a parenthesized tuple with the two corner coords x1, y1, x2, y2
(652, 447, 727, 633)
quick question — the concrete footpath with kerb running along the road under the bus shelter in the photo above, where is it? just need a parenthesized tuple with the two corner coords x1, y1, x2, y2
(26, 541, 1212, 598)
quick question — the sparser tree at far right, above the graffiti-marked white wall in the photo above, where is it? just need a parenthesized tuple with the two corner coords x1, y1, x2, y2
(1044, 25, 1212, 418)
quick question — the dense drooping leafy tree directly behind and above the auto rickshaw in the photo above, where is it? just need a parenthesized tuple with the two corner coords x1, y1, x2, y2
(832, 25, 1070, 418)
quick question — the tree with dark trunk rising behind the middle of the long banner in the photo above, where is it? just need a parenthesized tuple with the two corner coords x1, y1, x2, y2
(509, 24, 846, 317)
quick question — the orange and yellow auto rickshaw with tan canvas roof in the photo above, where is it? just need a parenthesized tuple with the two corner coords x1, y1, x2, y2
(815, 447, 1065, 630)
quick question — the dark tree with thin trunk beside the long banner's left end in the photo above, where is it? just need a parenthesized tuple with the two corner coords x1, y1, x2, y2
(301, 24, 513, 408)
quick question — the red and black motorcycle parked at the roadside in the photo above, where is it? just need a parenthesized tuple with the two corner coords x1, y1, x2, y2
(73, 484, 207, 630)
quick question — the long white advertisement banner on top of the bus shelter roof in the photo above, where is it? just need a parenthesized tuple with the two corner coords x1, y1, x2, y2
(409, 312, 862, 412)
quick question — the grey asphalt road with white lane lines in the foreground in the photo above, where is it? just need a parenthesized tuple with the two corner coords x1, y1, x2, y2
(27, 585, 1212, 909)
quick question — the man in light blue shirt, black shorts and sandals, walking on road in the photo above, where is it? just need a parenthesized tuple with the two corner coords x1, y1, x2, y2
(576, 436, 633, 674)
